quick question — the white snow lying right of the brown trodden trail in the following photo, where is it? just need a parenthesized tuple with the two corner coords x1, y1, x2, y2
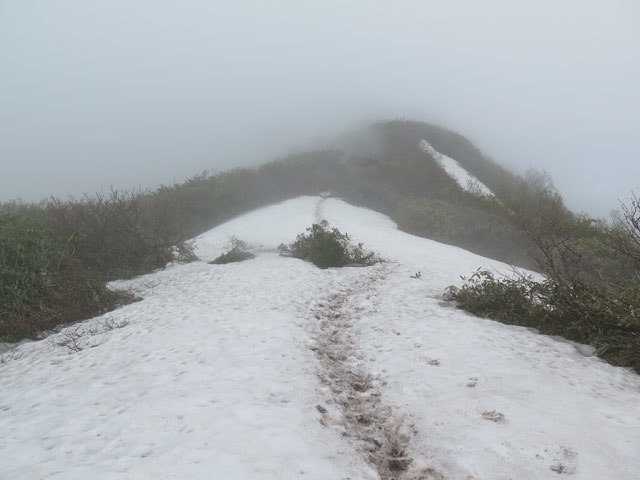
(323, 200, 640, 479)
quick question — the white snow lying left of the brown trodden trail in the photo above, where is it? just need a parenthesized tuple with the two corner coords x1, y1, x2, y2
(0, 200, 375, 479)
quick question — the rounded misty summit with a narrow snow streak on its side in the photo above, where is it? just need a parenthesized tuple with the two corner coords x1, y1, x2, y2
(276, 120, 528, 264)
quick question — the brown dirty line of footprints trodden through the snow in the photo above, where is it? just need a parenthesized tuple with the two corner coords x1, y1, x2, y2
(309, 199, 444, 480)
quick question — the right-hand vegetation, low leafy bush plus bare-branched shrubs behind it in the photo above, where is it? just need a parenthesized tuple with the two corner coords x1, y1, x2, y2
(448, 180, 640, 372)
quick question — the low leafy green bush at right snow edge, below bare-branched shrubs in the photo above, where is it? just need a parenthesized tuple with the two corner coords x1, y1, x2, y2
(446, 270, 640, 373)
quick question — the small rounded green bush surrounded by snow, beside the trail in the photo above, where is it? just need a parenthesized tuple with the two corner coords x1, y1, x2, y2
(278, 220, 381, 268)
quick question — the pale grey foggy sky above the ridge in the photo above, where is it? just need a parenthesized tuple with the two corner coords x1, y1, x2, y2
(0, 0, 640, 217)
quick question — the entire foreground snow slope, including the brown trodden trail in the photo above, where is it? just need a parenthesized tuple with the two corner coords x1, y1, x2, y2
(0, 197, 640, 480)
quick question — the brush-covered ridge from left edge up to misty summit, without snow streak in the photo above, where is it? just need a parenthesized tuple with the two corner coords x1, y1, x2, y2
(0, 121, 527, 340)
